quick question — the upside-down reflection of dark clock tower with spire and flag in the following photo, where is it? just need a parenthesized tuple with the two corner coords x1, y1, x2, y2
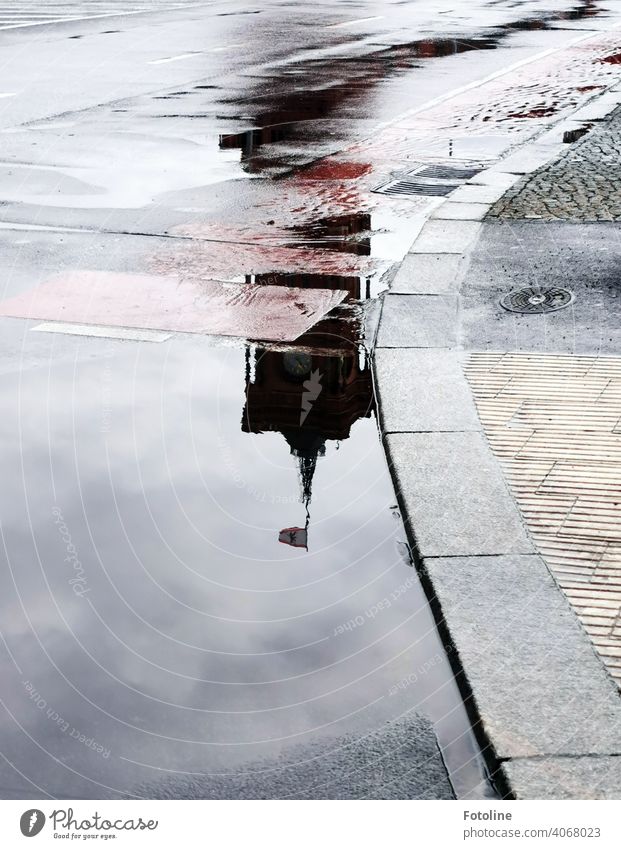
(242, 337, 373, 547)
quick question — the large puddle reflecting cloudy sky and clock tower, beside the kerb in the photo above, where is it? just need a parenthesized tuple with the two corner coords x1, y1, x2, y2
(0, 322, 490, 798)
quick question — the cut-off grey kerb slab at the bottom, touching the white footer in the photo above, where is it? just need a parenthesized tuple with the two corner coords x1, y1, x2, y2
(501, 757, 621, 800)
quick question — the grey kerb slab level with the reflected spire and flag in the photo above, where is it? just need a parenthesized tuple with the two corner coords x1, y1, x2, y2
(380, 430, 534, 557)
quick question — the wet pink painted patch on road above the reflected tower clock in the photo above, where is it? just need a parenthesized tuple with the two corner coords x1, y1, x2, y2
(0, 271, 347, 342)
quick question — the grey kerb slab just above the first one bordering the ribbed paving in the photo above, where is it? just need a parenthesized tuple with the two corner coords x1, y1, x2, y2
(377, 294, 457, 348)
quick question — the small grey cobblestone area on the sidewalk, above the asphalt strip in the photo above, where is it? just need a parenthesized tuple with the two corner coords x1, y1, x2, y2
(490, 103, 621, 221)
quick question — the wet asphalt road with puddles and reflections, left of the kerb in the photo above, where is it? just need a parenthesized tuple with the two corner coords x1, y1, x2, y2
(0, 2, 615, 798)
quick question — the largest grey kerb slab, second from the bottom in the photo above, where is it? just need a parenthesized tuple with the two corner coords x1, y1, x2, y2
(424, 555, 621, 759)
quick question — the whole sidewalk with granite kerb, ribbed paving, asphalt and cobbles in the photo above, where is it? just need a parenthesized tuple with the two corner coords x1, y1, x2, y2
(376, 86, 621, 799)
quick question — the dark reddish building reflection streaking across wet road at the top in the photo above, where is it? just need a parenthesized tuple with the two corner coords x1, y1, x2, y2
(218, 0, 614, 174)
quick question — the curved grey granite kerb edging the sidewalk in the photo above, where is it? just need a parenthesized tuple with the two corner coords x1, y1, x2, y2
(375, 89, 621, 799)
